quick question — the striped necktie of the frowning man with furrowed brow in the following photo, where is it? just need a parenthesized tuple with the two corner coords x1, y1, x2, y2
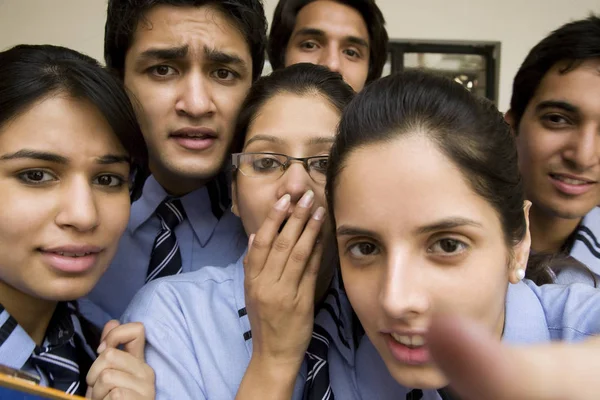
(146, 198, 186, 283)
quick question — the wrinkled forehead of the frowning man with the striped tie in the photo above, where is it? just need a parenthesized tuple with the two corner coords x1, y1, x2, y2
(127, 5, 251, 64)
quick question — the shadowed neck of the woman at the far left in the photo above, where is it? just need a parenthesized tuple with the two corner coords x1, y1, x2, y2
(0, 281, 58, 345)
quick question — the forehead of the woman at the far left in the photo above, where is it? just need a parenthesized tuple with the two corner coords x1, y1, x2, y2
(0, 95, 125, 156)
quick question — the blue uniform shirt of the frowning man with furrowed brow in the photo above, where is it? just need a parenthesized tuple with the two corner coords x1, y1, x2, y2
(79, 176, 248, 326)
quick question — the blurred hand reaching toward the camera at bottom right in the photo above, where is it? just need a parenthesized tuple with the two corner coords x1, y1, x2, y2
(428, 317, 600, 400)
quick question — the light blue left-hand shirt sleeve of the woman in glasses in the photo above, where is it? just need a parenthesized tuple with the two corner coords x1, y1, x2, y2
(121, 284, 207, 400)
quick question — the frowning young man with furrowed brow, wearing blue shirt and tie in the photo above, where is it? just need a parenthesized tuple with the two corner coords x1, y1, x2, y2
(80, 0, 266, 324)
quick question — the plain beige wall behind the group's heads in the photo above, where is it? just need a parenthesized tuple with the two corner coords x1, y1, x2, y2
(0, 0, 600, 110)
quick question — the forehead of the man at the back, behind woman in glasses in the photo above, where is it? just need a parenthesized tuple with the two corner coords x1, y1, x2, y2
(294, 0, 369, 41)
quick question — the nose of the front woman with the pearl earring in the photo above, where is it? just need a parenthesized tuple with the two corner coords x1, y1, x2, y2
(379, 252, 430, 320)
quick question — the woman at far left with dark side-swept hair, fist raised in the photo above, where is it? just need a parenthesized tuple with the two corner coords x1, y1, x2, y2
(0, 45, 154, 399)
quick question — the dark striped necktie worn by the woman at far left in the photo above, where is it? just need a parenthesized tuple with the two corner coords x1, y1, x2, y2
(30, 303, 91, 396)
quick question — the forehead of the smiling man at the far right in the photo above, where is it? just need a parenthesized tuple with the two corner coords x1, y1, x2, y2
(529, 58, 600, 118)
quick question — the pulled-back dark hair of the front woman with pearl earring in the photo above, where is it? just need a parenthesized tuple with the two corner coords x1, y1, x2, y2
(326, 71, 550, 279)
